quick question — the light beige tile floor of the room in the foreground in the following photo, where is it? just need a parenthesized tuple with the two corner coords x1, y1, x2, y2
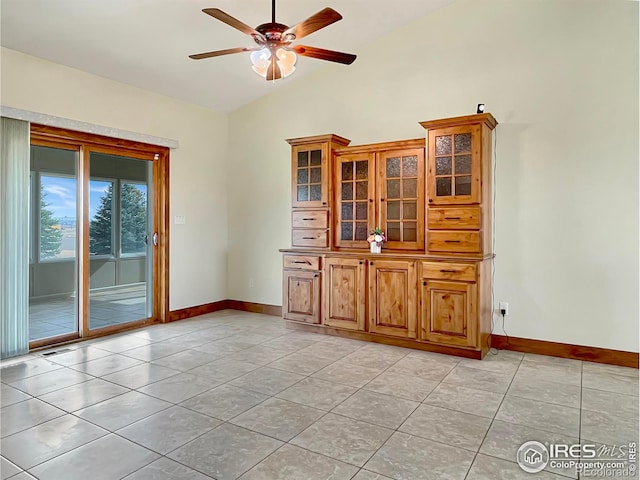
(0, 310, 638, 480)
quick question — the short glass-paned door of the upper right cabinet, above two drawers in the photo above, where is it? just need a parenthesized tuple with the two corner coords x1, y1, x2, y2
(428, 125, 480, 205)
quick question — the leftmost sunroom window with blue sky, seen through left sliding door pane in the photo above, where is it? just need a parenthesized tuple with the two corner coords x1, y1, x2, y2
(40, 175, 76, 260)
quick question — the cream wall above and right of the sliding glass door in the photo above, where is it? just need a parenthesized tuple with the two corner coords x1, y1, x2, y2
(0, 48, 228, 310)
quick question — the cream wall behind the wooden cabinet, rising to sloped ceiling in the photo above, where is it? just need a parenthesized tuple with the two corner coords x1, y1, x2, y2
(228, 0, 639, 351)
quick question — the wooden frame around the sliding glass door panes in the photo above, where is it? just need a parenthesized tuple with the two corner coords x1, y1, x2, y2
(29, 124, 170, 349)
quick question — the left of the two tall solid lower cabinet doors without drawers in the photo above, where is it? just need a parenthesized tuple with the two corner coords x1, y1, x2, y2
(322, 257, 366, 331)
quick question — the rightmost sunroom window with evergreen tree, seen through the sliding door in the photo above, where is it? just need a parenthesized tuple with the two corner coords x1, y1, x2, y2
(120, 182, 147, 253)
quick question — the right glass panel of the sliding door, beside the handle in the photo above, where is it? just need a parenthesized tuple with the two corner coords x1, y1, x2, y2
(89, 152, 155, 330)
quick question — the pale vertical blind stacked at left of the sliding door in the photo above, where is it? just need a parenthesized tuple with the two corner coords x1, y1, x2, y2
(0, 117, 29, 358)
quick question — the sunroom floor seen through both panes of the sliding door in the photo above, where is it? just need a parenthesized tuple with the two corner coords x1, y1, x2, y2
(29, 284, 147, 341)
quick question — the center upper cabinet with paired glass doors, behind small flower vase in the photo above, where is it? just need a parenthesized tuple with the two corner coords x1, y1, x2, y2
(334, 139, 425, 251)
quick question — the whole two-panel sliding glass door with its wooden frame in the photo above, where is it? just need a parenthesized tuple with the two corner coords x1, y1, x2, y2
(29, 127, 167, 348)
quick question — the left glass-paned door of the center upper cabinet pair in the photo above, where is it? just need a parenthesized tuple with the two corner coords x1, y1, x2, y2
(334, 153, 375, 249)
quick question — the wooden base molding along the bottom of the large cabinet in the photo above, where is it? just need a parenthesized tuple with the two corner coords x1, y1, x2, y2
(286, 322, 481, 360)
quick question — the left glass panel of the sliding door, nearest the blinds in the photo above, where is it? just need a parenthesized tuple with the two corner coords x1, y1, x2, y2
(29, 145, 81, 341)
